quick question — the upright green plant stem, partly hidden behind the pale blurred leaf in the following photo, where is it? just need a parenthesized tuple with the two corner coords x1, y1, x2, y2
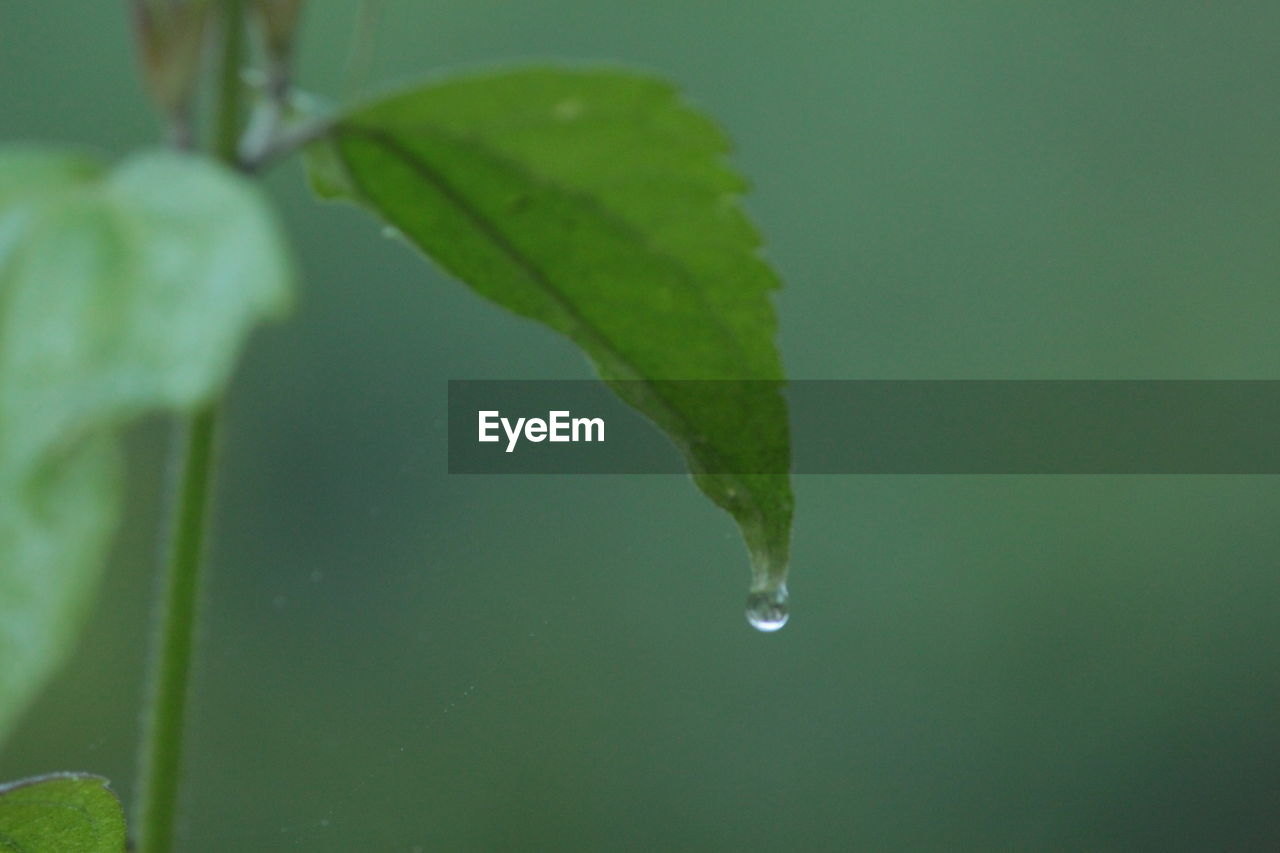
(136, 0, 244, 853)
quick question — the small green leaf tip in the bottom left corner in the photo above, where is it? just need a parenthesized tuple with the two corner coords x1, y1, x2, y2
(0, 774, 125, 853)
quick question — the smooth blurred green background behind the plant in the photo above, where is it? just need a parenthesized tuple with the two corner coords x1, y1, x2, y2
(0, 0, 1280, 852)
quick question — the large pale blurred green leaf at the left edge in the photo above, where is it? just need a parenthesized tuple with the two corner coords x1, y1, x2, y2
(0, 150, 292, 736)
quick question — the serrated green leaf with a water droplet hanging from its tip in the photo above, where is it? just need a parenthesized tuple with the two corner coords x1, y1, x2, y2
(311, 69, 792, 617)
